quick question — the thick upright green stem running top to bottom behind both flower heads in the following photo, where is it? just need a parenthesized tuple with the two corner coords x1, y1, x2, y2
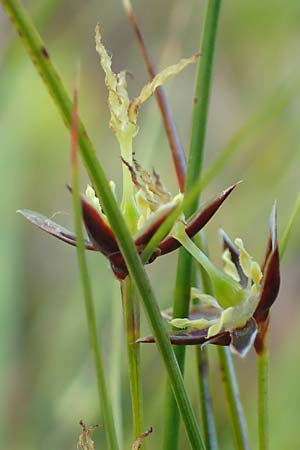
(163, 0, 221, 450)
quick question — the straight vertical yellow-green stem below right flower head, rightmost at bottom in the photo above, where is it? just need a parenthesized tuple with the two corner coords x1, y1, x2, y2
(257, 350, 270, 450)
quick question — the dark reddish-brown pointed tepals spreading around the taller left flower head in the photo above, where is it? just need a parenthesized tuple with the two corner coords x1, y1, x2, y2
(19, 185, 236, 280)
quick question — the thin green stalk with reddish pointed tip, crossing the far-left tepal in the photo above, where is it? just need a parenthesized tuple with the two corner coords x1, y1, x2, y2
(71, 87, 119, 450)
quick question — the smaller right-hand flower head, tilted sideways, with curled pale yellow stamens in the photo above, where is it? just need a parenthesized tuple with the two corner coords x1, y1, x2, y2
(139, 206, 280, 356)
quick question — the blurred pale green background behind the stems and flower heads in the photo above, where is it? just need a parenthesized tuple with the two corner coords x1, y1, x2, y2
(0, 0, 300, 450)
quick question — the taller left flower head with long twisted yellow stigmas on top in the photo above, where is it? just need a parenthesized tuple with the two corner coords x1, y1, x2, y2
(20, 26, 235, 279)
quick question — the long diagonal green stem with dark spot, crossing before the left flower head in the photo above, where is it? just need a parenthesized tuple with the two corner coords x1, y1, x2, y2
(1, 0, 204, 450)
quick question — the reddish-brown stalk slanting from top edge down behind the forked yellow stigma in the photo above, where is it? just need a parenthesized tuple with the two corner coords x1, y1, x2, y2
(122, 0, 186, 192)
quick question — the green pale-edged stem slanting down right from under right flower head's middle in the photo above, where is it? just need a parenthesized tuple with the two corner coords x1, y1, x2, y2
(218, 347, 250, 450)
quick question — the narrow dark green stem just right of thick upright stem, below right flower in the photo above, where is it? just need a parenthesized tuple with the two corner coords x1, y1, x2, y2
(196, 345, 218, 450)
